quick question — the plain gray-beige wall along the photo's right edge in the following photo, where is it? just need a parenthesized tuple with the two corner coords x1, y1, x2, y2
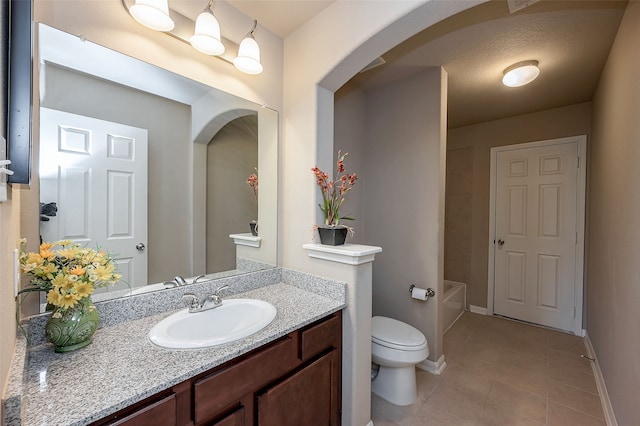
(587, 1, 640, 425)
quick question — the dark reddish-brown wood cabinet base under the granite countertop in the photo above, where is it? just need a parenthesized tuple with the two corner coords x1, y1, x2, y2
(93, 312, 342, 426)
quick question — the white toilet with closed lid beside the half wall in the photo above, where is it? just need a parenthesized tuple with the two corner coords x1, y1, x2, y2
(371, 316, 429, 405)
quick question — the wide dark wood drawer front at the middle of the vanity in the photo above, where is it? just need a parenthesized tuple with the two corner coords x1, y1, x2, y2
(193, 333, 298, 423)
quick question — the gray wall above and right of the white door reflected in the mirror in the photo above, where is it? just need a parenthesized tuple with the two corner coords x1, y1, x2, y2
(41, 66, 192, 286)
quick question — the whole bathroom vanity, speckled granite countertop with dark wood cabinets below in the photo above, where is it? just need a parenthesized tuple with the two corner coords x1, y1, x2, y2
(4, 272, 345, 426)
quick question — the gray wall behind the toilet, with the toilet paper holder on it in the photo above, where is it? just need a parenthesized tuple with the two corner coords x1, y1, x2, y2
(361, 68, 447, 361)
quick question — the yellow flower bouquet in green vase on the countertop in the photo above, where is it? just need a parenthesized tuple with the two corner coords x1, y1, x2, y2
(19, 239, 121, 352)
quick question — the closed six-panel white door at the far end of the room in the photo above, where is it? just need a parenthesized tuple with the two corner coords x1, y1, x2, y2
(494, 142, 580, 332)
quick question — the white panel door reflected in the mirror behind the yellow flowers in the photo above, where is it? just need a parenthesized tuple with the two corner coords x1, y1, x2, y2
(40, 108, 147, 290)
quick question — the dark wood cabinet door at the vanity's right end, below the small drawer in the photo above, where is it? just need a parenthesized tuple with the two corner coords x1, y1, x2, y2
(258, 350, 340, 426)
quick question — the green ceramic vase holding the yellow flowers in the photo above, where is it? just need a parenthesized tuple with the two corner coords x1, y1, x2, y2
(45, 297, 100, 352)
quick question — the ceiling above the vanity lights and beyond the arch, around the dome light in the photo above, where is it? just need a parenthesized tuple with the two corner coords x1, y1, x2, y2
(227, 0, 627, 127)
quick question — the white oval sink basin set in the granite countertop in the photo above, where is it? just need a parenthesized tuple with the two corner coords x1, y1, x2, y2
(149, 299, 276, 349)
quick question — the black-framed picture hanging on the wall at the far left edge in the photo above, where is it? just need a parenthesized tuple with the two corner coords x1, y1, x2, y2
(7, 0, 33, 184)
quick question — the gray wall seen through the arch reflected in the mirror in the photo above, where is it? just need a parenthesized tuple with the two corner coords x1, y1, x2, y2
(207, 115, 260, 274)
